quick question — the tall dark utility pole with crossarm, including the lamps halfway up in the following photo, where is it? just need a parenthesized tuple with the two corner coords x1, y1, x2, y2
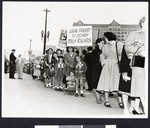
(41, 9, 50, 54)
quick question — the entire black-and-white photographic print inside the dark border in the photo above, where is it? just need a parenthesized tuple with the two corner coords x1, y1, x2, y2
(1, 1, 149, 118)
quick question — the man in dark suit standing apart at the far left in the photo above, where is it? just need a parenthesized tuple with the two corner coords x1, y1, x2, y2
(9, 49, 16, 79)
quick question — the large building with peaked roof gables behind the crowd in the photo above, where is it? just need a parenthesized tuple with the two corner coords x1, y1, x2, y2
(73, 20, 139, 44)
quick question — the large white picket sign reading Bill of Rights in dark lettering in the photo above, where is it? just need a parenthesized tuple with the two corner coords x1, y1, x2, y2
(67, 26, 92, 46)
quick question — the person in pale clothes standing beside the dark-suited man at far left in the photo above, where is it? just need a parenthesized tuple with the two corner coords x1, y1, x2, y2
(16, 54, 23, 79)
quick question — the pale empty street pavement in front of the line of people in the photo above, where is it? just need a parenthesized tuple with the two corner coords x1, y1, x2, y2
(2, 74, 123, 118)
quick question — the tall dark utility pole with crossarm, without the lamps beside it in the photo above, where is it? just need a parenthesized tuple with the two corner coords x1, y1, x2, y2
(43, 9, 50, 54)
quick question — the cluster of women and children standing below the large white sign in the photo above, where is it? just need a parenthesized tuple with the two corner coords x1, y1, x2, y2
(43, 47, 87, 97)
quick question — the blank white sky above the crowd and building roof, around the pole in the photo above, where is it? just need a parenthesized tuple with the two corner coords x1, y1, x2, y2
(2, 2, 148, 57)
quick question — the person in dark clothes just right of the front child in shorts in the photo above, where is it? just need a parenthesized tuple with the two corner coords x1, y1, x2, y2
(84, 47, 93, 91)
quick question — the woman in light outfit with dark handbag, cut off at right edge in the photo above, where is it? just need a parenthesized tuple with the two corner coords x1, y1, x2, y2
(119, 17, 145, 114)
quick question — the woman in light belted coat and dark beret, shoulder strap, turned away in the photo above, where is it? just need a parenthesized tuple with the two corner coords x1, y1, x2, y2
(97, 32, 123, 108)
